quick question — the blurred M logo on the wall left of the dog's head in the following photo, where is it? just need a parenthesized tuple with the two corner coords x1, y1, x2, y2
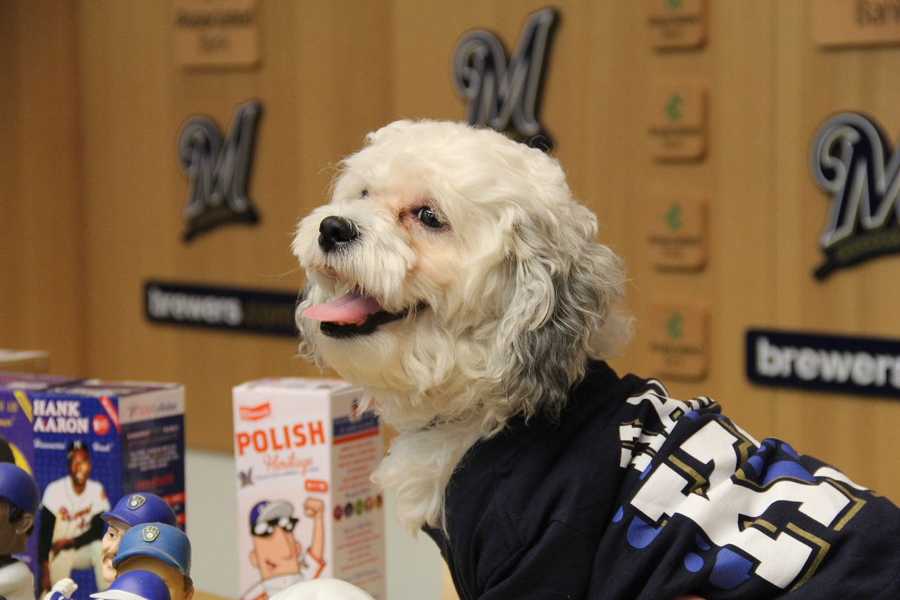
(178, 101, 263, 242)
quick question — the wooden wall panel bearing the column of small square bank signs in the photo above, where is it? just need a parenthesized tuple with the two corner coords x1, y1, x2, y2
(394, 1, 775, 440)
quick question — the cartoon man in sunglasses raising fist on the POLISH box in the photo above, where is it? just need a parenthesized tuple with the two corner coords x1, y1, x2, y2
(241, 498, 325, 600)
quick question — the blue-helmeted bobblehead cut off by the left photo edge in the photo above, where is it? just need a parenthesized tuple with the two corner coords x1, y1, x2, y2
(0, 462, 39, 600)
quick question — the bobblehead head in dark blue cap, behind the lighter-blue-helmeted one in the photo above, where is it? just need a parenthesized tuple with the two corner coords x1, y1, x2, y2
(101, 493, 176, 583)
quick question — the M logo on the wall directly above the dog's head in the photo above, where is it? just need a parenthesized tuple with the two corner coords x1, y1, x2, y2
(453, 8, 559, 150)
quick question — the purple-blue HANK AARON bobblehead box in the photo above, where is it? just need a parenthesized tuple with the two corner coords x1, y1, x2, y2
(0, 376, 185, 597)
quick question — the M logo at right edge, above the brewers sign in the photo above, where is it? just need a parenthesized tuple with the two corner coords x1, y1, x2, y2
(812, 112, 900, 280)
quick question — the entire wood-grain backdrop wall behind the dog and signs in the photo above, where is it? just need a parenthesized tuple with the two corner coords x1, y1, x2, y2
(0, 0, 900, 510)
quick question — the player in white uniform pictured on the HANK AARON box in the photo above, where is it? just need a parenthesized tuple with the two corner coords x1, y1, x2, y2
(38, 441, 109, 591)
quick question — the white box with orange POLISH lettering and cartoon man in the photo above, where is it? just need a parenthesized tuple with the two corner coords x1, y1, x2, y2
(234, 378, 385, 600)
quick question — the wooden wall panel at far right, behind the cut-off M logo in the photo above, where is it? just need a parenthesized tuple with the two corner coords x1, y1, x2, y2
(760, 2, 900, 494)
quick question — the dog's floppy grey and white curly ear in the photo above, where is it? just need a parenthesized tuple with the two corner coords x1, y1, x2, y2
(493, 202, 630, 424)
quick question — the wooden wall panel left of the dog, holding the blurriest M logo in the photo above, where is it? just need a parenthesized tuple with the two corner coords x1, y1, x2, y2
(79, 2, 390, 452)
